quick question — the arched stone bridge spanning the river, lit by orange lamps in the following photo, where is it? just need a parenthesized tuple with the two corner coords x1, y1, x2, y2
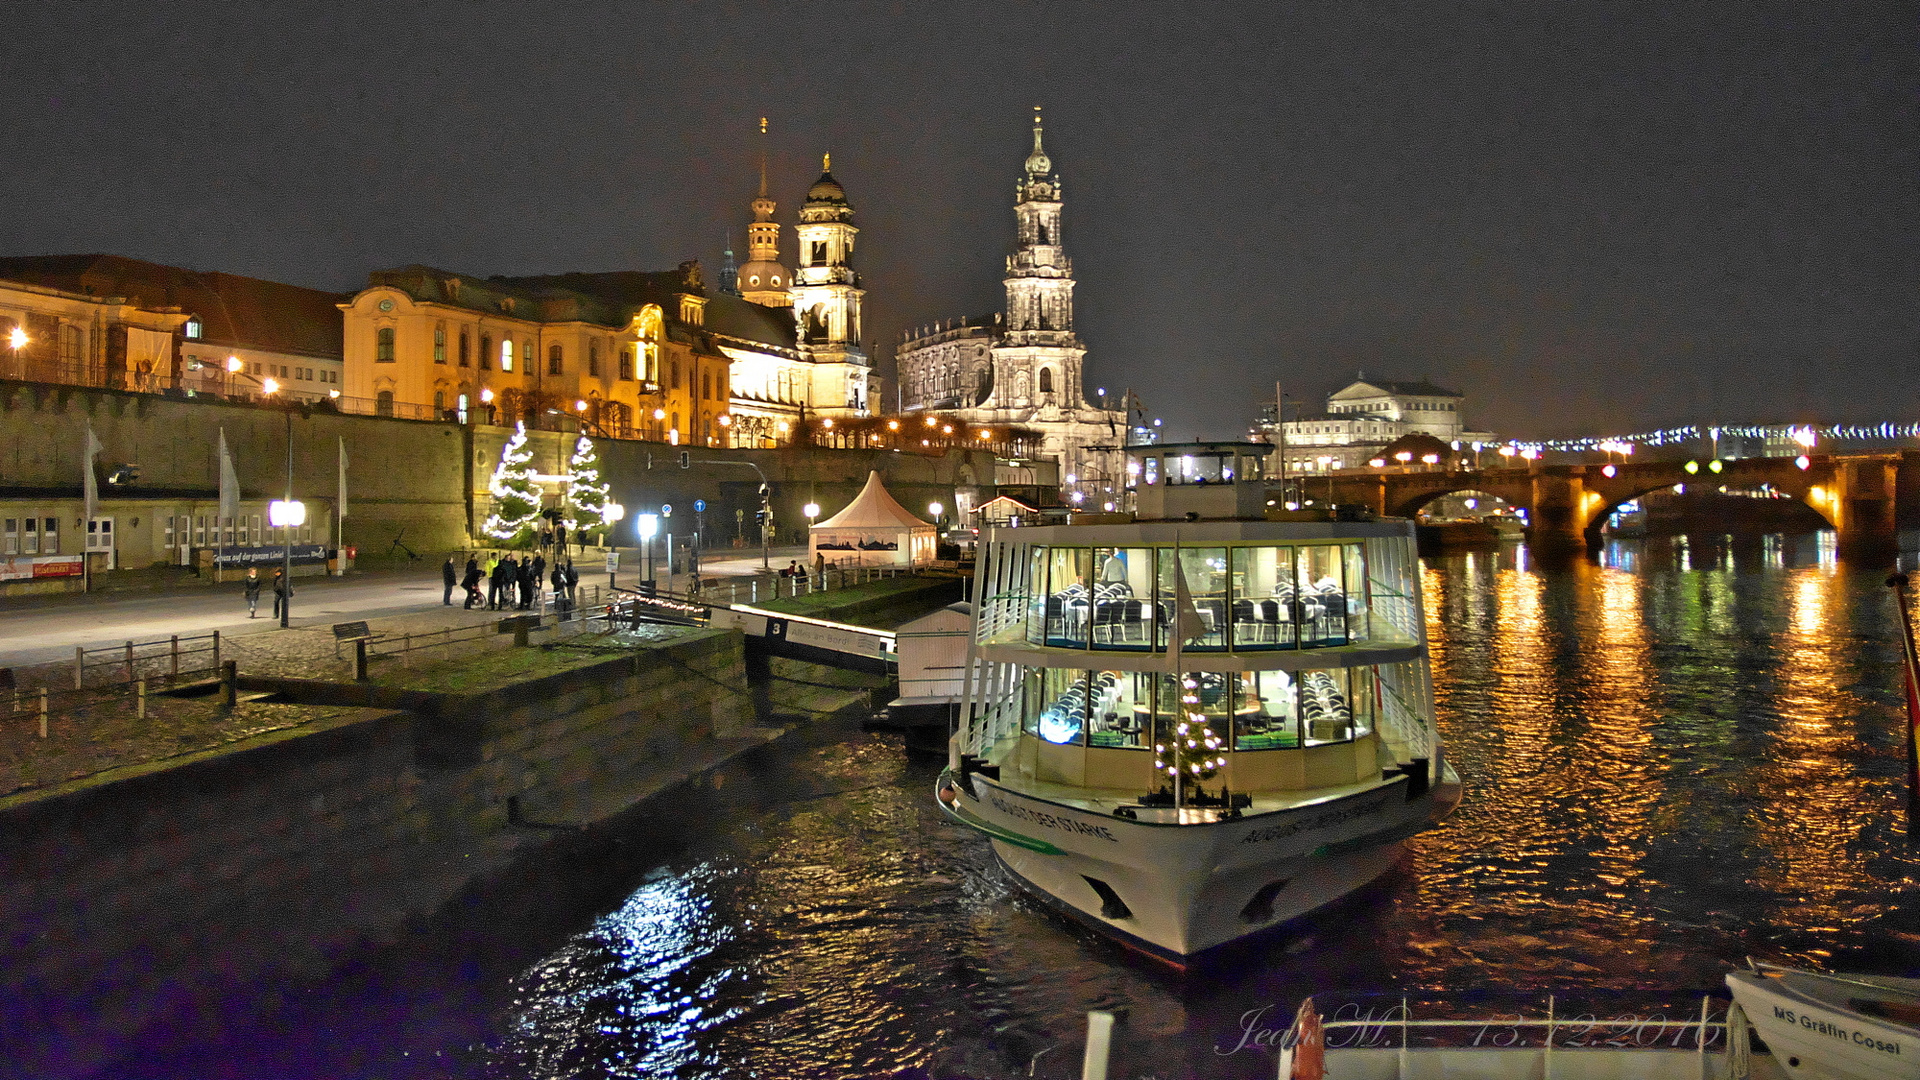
(1328, 452, 1920, 552)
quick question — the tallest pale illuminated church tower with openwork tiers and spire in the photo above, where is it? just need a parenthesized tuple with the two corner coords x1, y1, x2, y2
(995, 106, 1087, 409)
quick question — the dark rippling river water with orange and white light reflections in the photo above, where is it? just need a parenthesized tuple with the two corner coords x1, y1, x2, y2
(120, 536, 1920, 1078)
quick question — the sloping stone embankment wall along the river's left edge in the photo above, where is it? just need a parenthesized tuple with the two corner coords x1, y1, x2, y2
(0, 630, 752, 1078)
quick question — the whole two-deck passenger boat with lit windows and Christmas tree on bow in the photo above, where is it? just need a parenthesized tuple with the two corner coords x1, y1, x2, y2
(935, 444, 1459, 967)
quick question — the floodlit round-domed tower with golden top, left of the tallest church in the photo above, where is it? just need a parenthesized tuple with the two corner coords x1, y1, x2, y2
(789, 156, 872, 415)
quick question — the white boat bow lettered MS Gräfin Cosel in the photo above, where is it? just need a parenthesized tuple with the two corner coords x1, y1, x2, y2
(1726, 963, 1920, 1080)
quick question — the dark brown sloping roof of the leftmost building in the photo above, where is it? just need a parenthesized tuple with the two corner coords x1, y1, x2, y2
(0, 254, 346, 359)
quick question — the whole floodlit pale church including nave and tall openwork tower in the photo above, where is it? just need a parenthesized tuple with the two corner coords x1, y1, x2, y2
(895, 110, 1127, 509)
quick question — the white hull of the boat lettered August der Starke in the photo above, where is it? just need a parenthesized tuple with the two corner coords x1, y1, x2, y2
(941, 774, 1459, 967)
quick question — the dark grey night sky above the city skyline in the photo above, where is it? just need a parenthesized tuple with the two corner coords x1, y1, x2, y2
(0, 0, 1920, 438)
